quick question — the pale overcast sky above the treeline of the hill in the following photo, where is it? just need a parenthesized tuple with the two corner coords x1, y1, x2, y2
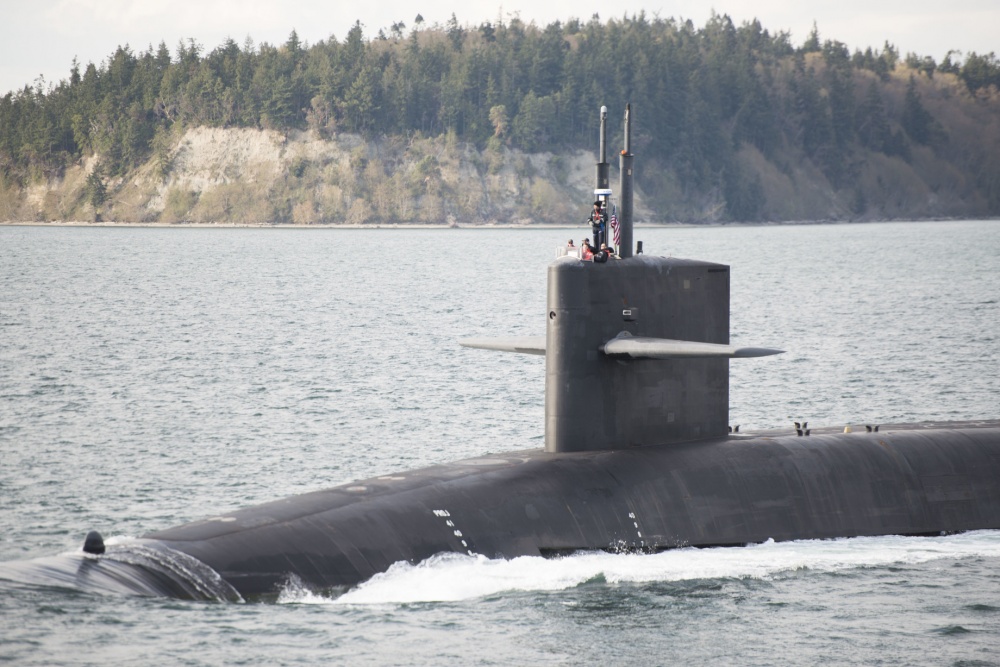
(0, 0, 1000, 95)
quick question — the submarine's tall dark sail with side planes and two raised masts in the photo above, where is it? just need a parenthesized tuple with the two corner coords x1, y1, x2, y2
(461, 107, 780, 452)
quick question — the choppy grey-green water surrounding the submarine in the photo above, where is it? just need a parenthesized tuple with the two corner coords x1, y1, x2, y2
(0, 221, 1000, 665)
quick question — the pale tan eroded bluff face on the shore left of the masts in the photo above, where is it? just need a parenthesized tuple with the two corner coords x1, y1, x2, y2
(0, 127, 641, 224)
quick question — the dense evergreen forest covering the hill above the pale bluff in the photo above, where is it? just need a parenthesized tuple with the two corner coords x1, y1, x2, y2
(0, 14, 1000, 222)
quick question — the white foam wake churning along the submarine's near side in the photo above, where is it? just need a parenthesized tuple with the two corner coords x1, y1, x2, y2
(279, 530, 1000, 604)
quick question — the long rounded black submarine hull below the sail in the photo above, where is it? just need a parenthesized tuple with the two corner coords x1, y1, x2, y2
(144, 421, 1000, 596)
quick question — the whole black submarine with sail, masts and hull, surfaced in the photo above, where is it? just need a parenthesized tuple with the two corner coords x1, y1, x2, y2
(0, 106, 1000, 601)
